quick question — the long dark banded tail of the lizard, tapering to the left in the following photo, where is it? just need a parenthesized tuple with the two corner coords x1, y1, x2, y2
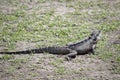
(0, 46, 69, 54)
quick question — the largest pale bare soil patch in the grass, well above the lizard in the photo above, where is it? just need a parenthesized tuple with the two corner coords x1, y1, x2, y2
(28, 1, 75, 16)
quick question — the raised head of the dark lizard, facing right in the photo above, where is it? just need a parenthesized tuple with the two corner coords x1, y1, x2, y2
(89, 31, 101, 43)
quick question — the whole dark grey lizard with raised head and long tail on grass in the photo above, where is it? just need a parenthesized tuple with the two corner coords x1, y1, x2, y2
(0, 31, 101, 60)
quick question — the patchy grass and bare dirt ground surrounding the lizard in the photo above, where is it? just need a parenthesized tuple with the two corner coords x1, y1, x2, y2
(0, 0, 120, 80)
